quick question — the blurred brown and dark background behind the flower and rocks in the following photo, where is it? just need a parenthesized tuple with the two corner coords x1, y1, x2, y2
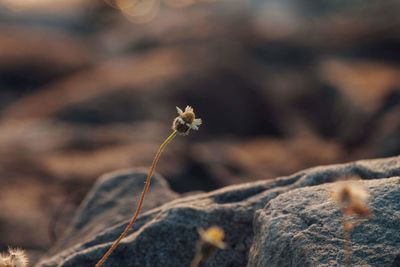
(0, 0, 400, 264)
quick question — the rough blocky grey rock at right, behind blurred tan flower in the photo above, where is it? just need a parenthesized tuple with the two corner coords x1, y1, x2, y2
(248, 177, 400, 267)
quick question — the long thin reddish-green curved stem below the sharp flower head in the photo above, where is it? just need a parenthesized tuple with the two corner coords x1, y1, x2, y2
(96, 131, 178, 267)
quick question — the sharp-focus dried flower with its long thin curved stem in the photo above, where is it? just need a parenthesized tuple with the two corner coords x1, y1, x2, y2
(95, 106, 202, 267)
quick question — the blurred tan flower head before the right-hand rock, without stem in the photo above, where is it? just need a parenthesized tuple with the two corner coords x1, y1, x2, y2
(332, 181, 371, 217)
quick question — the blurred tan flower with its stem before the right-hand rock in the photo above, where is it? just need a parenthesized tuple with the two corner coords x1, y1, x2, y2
(332, 181, 371, 266)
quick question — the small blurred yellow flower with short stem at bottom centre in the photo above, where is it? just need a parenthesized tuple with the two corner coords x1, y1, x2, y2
(190, 226, 226, 267)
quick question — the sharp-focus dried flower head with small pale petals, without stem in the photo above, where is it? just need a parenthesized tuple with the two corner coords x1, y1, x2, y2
(172, 106, 202, 135)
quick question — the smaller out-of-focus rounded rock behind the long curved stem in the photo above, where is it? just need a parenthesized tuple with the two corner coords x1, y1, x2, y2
(49, 169, 179, 255)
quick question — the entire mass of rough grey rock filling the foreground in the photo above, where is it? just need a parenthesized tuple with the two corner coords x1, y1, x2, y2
(36, 157, 400, 267)
